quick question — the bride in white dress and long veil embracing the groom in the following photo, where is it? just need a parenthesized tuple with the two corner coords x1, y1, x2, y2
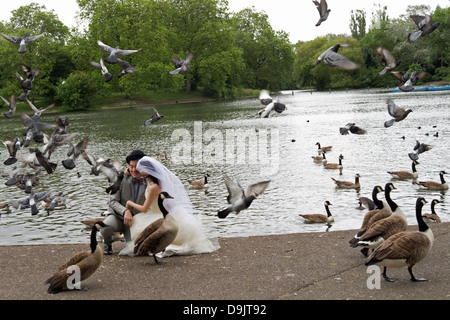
(119, 156, 219, 256)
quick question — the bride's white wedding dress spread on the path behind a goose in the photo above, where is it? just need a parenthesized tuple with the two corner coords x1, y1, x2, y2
(119, 184, 220, 257)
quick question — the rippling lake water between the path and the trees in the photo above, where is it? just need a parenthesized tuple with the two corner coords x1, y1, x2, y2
(0, 90, 450, 245)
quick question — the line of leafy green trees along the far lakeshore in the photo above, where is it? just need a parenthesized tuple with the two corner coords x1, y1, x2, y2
(0, 0, 450, 110)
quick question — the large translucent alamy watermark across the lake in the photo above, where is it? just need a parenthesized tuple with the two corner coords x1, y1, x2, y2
(171, 121, 280, 174)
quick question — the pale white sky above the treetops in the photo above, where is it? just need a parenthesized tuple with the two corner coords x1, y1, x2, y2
(0, 0, 450, 43)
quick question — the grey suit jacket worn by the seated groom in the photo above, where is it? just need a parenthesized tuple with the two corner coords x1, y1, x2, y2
(108, 174, 146, 220)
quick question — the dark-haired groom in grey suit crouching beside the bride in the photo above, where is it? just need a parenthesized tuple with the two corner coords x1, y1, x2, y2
(100, 150, 146, 255)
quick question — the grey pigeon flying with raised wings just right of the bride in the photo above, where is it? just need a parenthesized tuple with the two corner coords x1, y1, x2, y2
(217, 175, 270, 219)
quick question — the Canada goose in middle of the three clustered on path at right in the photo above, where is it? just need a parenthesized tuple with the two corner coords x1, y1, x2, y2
(351, 183, 408, 249)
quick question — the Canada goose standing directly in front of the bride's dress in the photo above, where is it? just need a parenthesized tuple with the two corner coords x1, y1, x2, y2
(134, 191, 178, 264)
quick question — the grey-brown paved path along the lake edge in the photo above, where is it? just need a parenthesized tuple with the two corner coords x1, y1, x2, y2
(0, 223, 450, 306)
